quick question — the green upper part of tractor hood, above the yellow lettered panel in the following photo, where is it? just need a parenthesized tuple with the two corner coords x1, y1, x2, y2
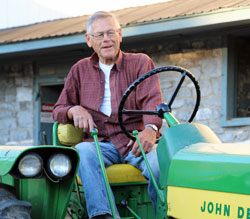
(168, 143, 250, 195)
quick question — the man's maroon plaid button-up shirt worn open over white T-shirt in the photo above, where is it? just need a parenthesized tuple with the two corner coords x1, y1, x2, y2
(53, 51, 162, 156)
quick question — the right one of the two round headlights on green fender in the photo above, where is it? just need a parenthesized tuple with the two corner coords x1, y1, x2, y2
(49, 154, 72, 178)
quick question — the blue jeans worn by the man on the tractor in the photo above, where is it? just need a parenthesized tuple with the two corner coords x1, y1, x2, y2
(76, 142, 160, 218)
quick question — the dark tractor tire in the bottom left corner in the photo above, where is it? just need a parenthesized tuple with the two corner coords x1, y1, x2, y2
(0, 184, 31, 219)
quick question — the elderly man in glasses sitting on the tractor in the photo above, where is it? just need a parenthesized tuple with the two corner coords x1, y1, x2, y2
(53, 12, 162, 218)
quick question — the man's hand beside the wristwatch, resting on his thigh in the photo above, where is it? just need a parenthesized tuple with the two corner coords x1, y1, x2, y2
(127, 127, 156, 157)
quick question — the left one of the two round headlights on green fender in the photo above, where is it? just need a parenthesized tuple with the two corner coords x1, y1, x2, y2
(18, 154, 43, 177)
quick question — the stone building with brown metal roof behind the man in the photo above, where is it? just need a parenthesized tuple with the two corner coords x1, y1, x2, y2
(0, 0, 250, 145)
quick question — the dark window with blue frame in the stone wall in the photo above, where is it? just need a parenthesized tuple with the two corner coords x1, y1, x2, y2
(221, 37, 250, 126)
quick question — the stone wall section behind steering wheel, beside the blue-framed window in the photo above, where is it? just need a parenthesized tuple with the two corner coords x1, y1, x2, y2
(152, 48, 250, 142)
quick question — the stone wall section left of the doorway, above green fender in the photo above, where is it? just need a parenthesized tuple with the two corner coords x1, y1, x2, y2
(0, 63, 34, 145)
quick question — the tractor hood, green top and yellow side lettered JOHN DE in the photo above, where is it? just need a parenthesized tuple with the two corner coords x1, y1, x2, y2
(167, 143, 250, 219)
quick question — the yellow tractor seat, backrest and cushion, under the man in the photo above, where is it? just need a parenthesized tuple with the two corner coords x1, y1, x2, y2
(53, 122, 147, 185)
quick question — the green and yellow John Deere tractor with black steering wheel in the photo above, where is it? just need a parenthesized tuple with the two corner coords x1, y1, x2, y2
(0, 66, 250, 219)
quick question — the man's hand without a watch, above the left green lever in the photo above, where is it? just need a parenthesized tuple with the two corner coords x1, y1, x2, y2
(67, 106, 96, 132)
